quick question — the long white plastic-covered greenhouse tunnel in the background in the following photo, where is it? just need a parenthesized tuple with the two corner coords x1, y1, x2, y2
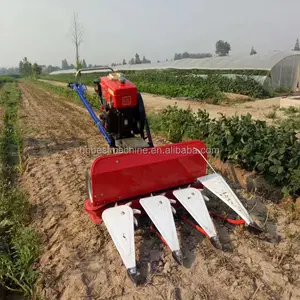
(51, 51, 300, 91)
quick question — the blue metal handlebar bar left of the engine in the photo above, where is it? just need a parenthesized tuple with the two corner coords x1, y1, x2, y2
(68, 83, 115, 147)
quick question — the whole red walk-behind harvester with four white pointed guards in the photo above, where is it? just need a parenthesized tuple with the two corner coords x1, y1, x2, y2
(68, 68, 261, 283)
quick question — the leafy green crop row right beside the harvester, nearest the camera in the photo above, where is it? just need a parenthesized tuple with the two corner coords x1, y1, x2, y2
(150, 106, 300, 196)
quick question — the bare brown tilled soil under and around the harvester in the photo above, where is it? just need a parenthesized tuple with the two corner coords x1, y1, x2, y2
(19, 82, 300, 300)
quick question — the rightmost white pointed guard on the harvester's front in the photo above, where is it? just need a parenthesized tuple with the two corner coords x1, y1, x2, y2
(197, 173, 253, 225)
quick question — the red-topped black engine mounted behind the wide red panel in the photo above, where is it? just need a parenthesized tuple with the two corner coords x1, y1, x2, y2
(94, 73, 144, 139)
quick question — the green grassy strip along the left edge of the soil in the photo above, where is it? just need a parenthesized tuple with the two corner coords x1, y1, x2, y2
(0, 82, 39, 299)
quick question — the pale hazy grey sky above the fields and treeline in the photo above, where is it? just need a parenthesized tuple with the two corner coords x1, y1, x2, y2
(0, 0, 300, 67)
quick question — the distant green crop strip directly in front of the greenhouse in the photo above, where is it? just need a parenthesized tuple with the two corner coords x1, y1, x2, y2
(44, 70, 269, 100)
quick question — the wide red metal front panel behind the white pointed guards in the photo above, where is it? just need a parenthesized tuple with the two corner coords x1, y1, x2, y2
(85, 141, 207, 223)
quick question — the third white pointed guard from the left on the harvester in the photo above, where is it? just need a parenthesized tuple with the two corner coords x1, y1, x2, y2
(173, 188, 217, 238)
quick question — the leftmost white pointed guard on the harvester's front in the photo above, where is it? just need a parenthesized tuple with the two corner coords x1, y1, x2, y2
(102, 205, 136, 269)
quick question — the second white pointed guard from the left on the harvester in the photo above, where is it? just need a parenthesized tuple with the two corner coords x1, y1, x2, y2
(140, 196, 180, 251)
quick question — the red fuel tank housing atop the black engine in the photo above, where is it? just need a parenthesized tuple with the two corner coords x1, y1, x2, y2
(100, 74, 137, 109)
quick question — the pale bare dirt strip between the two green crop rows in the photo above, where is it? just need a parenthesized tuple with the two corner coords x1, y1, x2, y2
(41, 80, 282, 123)
